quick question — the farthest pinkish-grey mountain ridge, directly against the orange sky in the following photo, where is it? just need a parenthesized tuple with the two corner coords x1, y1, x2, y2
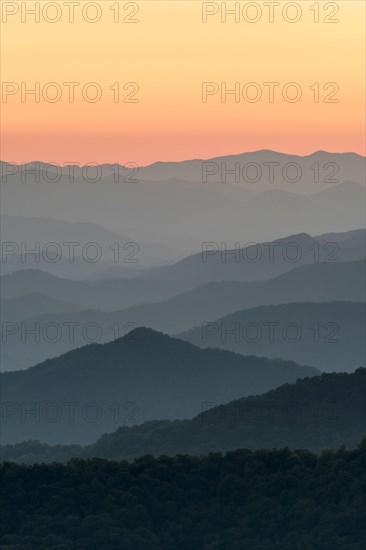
(1, 149, 365, 192)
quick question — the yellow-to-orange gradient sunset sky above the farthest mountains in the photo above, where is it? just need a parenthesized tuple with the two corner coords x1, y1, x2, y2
(1, 0, 365, 165)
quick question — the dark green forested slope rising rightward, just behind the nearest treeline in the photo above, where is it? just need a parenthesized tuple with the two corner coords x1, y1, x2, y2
(2, 368, 366, 463)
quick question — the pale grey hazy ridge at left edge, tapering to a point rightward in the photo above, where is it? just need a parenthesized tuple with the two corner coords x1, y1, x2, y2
(1, 216, 187, 279)
